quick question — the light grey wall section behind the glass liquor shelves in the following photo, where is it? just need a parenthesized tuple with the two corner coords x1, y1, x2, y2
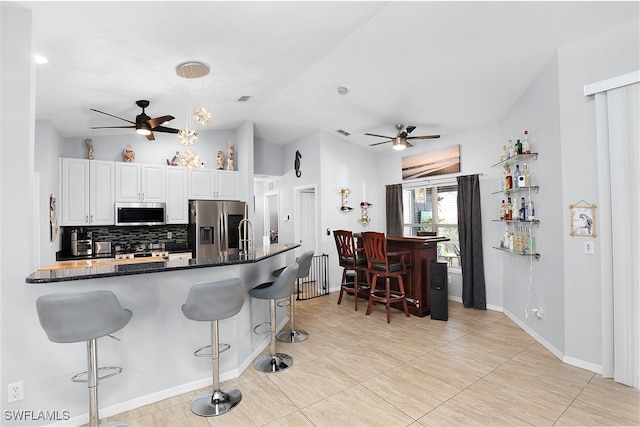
(501, 52, 565, 357)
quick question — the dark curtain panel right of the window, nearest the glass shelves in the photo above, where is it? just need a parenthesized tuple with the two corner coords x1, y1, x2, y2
(458, 175, 487, 310)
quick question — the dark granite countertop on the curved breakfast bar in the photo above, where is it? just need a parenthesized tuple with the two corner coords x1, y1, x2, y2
(25, 243, 300, 284)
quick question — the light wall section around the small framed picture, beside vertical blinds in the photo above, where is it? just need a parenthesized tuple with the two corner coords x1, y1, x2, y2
(558, 20, 640, 368)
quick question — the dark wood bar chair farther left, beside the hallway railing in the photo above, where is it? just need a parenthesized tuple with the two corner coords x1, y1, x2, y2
(333, 230, 371, 311)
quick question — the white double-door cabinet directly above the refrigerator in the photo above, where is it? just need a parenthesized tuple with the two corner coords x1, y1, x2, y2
(189, 169, 240, 200)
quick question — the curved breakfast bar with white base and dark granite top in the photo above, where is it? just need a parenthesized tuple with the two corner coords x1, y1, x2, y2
(16, 243, 300, 425)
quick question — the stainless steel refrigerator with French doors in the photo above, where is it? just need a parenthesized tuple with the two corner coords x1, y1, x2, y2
(188, 200, 247, 259)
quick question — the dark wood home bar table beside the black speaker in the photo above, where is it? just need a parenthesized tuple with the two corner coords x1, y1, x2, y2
(387, 236, 449, 317)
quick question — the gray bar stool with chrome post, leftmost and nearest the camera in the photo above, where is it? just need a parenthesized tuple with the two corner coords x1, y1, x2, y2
(36, 291, 132, 427)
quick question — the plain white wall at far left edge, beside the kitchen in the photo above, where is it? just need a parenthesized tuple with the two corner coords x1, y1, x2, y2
(0, 2, 36, 418)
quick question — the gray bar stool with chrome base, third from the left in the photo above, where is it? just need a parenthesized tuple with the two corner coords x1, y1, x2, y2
(249, 262, 300, 372)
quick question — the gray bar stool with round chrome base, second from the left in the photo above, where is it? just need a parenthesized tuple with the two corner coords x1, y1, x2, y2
(182, 278, 245, 417)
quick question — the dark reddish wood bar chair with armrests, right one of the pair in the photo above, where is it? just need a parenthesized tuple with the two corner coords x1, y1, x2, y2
(362, 231, 410, 323)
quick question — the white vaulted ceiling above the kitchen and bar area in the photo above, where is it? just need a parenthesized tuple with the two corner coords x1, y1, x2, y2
(18, 1, 640, 150)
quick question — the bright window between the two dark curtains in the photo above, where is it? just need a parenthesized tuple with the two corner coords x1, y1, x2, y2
(402, 181, 461, 270)
